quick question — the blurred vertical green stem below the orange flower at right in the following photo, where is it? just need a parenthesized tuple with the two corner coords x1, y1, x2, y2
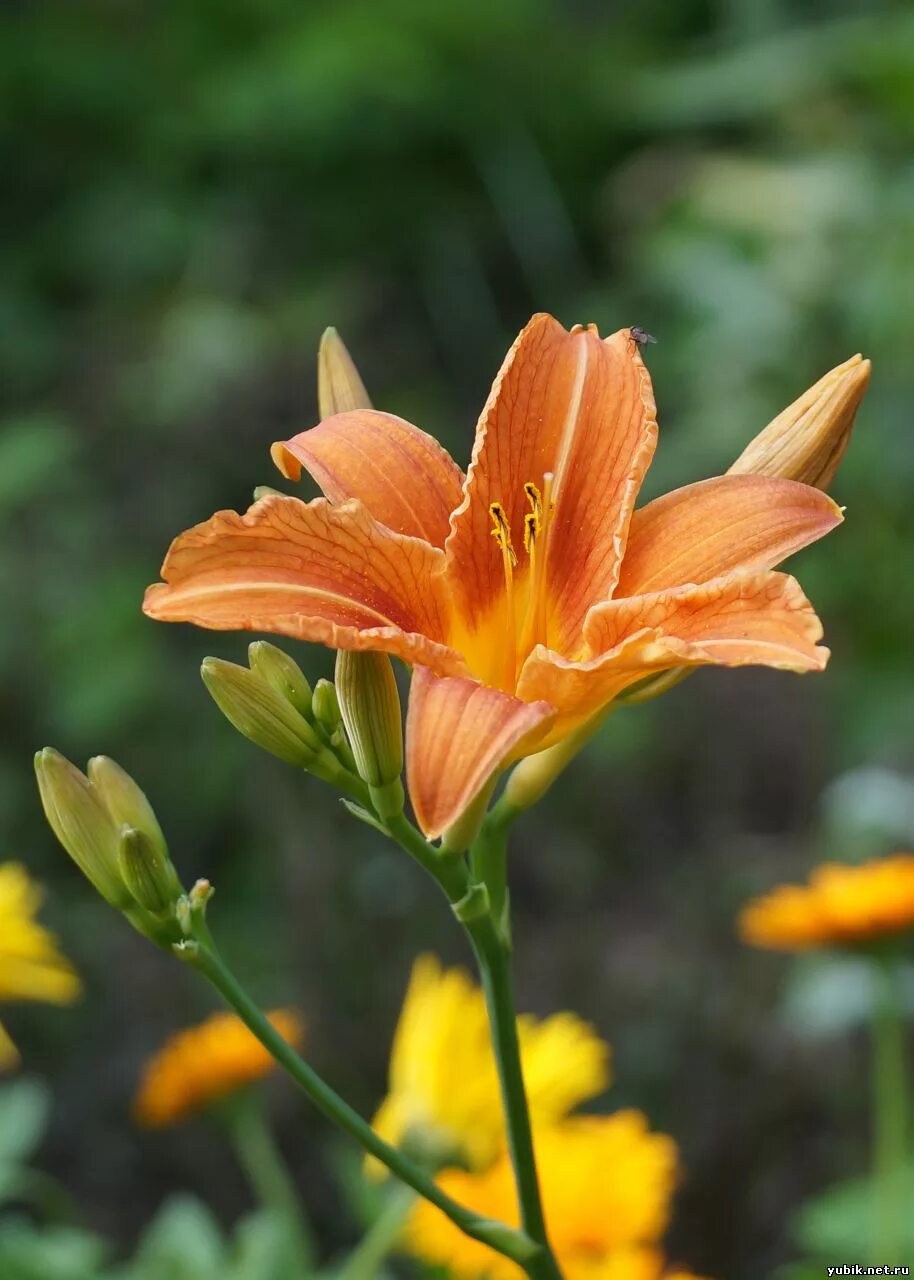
(872, 956, 910, 1262)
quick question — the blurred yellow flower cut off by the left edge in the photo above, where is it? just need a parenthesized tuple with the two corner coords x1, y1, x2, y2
(0, 863, 79, 1070)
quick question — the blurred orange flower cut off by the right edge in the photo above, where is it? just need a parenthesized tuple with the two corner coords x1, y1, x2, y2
(739, 854, 914, 951)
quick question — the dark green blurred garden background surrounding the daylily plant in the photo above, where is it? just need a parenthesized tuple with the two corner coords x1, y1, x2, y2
(0, 0, 914, 1280)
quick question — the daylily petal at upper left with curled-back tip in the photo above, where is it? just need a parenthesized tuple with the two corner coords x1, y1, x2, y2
(271, 410, 463, 547)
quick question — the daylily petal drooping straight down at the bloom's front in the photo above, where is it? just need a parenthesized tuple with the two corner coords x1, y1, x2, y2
(406, 667, 556, 840)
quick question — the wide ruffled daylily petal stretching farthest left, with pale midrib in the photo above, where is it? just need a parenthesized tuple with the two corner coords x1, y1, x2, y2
(143, 494, 466, 675)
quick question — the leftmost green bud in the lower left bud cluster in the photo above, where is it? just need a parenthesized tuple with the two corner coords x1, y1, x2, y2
(35, 746, 132, 910)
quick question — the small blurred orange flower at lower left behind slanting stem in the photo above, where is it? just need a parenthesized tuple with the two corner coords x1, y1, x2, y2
(133, 1009, 303, 1129)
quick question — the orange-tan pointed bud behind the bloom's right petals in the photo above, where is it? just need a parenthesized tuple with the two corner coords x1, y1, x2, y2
(728, 356, 872, 489)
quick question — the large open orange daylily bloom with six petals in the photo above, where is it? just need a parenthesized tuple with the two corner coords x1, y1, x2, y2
(143, 315, 841, 838)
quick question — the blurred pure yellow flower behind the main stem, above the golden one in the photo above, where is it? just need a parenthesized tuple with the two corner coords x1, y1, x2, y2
(370, 955, 609, 1172)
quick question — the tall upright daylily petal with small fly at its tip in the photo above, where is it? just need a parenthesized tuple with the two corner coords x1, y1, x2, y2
(445, 315, 657, 645)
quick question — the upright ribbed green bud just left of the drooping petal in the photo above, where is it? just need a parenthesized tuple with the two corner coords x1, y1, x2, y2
(337, 649, 403, 818)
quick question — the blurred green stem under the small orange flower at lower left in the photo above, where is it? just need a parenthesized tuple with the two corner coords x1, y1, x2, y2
(223, 1092, 317, 1275)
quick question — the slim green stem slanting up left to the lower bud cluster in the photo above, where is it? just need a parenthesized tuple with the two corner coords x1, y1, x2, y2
(179, 941, 552, 1280)
